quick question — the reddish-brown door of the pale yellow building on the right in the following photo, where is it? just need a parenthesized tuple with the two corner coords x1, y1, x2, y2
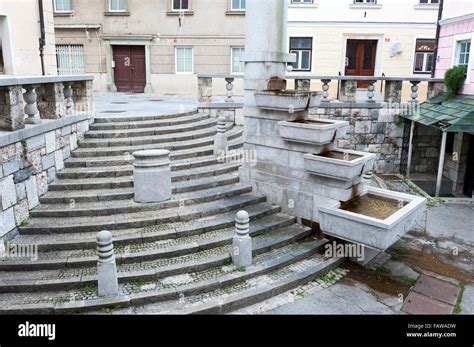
(345, 40, 377, 88)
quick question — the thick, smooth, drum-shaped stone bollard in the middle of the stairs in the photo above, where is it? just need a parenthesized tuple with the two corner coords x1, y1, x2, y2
(133, 149, 172, 203)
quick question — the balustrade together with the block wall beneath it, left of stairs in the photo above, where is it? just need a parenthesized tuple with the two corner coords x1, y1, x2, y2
(0, 76, 93, 242)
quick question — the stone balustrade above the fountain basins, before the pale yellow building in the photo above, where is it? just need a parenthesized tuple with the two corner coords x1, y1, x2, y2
(287, 76, 445, 104)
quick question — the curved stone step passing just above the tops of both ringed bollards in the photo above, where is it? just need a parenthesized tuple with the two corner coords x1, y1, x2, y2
(20, 194, 266, 234)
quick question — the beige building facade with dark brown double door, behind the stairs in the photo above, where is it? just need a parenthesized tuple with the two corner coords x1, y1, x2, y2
(53, 0, 245, 94)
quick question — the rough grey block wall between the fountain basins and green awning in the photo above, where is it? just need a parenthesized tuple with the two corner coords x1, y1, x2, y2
(311, 103, 404, 174)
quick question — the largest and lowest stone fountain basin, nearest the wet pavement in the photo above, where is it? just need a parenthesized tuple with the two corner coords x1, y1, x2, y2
(319, 187, 426, 251)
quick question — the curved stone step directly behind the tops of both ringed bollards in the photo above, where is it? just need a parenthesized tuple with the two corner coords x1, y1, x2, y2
(12, 203, 282, 252)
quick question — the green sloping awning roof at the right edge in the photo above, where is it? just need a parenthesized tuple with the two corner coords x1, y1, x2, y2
(400, 95, 474, 132)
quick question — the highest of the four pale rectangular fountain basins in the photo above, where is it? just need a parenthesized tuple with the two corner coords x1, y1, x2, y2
(255, 90, 318, 113)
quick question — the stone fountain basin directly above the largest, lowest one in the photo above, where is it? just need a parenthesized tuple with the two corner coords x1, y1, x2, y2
(304, 149, 376, 181)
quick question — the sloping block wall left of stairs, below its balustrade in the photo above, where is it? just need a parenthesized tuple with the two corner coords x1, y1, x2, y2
(0, 115, 90, 239)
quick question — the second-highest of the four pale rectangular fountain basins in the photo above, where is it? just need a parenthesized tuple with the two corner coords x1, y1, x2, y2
(278, 119, 349, 145)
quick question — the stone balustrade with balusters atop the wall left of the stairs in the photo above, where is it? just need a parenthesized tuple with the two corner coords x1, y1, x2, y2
(0, 76, 93, 131)
